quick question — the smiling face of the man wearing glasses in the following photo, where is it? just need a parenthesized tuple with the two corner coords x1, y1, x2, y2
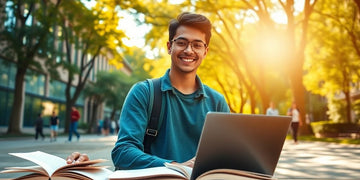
(167, 26, 208, 74)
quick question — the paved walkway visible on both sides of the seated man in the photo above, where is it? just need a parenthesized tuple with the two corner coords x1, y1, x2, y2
(0, 135, 360, 179)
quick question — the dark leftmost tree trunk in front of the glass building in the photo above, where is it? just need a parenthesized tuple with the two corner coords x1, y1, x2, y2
(7, 68, 26, 134)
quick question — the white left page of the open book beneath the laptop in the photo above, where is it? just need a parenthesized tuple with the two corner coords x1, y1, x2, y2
(109, 166, 187, 180)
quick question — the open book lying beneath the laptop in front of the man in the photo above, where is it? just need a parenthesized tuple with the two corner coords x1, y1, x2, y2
(109, 163, 273, 180)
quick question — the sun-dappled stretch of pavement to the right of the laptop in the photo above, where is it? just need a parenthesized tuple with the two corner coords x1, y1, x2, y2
(275, 141, 360, 179)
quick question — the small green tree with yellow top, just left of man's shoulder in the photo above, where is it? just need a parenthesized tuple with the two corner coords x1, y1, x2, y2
(84, 47, 154, 133)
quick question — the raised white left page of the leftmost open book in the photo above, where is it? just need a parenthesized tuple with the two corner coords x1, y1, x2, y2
(9, 151, 67, 177)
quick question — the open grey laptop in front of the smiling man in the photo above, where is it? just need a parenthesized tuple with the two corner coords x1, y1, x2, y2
(191, 112, 291, 180)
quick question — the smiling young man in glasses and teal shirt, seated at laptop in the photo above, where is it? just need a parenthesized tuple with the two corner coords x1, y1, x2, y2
(68, 13, 229, 169)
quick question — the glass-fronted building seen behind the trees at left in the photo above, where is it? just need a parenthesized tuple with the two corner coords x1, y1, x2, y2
(0, 0, 131, 129)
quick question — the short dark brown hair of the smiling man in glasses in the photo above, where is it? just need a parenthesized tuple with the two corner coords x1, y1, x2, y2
(169, 12, 211, 45)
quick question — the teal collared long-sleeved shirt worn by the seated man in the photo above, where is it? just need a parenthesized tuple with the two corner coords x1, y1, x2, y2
(111, 70, 230, 169)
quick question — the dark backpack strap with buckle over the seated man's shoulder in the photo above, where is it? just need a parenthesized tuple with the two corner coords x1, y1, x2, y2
(143, 78, 162, 154)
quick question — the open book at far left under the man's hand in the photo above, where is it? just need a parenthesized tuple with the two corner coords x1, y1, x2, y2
(0, 151, 112, 180)
